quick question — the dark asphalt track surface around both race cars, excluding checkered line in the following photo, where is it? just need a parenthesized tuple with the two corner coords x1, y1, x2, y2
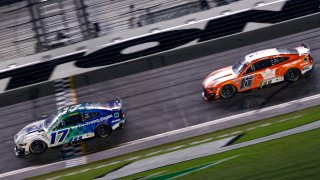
(0, 28, 320, 173)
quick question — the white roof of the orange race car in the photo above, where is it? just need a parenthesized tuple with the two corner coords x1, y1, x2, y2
(245, 48, 299, 63)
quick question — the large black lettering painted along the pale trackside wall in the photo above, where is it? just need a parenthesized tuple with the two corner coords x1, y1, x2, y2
(0, 0, 320, 90)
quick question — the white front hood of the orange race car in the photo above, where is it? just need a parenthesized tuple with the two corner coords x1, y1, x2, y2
(202, 66, 236, 88)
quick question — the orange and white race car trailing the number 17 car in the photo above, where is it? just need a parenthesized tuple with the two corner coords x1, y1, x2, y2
(202, 44, 314, 101)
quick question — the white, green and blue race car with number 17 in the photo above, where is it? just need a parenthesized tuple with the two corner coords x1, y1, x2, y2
(14, 99, 126, 156)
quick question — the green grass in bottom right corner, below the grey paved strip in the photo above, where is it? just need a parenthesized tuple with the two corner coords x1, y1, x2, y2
(122, 129, 320, 180)
